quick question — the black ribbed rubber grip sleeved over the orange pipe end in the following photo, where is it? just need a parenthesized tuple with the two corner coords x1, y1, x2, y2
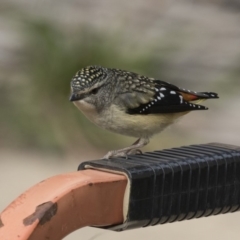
(79, 143, 240, 231)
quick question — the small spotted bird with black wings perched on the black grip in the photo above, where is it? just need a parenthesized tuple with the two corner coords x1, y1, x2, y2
(70, 66, 218, 159)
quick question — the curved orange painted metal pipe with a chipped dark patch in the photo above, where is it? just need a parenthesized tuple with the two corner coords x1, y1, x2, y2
(0, 170, 127, 240)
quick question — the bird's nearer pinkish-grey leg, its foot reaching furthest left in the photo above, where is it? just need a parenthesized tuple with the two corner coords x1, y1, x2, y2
(103, 138, 149, 159)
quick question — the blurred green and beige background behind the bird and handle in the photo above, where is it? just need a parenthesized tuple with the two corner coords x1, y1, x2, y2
(0, 0, 240, 240)
